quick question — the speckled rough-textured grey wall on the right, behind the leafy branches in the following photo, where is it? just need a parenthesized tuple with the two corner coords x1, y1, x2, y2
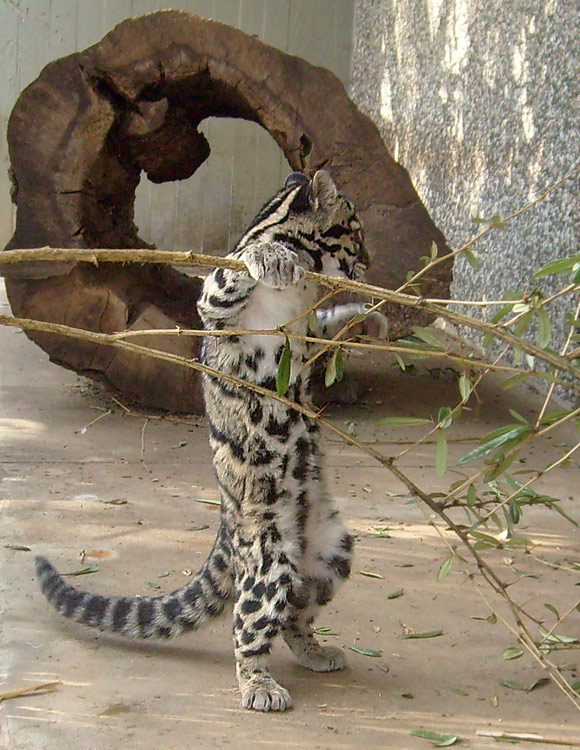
(351, 0, 580, 362)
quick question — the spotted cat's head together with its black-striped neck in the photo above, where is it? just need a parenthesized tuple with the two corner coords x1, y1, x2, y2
(240, 170, 370, 279)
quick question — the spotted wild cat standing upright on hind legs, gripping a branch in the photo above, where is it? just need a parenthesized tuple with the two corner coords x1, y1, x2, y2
(36, 171, 384, 711)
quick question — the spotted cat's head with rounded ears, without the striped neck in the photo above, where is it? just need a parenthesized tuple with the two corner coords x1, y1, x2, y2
(283, 170, 370, 279)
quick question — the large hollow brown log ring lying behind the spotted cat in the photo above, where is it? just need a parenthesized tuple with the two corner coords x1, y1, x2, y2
(0, 10, 451, 413)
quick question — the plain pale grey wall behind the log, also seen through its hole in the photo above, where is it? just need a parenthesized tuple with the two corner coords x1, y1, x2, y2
(0, 0, 354, 253)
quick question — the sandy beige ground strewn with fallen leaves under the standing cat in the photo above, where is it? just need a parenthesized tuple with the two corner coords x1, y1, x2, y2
(0, 284, 580, 750)
